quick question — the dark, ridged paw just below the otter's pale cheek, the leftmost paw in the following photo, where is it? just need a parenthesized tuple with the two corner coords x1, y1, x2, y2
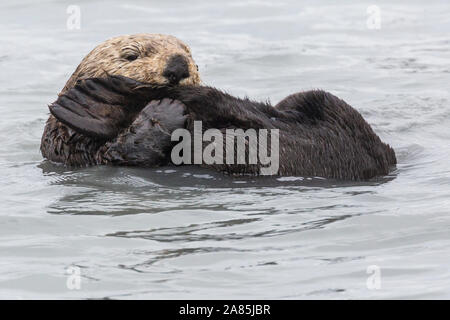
(49, 76, 155, 140)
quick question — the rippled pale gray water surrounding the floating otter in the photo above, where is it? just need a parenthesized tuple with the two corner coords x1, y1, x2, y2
(0, 0, 450, 299)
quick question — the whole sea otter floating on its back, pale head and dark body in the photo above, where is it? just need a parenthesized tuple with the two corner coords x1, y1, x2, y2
(41, 34, 396, 180)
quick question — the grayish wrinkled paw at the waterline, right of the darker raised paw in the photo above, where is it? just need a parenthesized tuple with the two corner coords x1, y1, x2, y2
(99, 98, 187, 166)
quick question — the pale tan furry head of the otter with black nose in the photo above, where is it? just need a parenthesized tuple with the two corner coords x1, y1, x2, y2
(61, 33, 201, 93)
